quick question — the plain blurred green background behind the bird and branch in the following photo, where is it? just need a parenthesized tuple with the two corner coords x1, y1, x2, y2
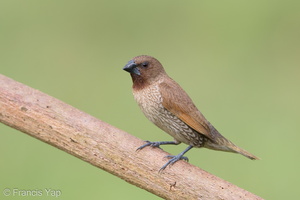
(0, 0, 300, 200)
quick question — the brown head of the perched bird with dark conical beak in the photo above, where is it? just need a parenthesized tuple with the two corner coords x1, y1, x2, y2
(123, 55, 166, 89)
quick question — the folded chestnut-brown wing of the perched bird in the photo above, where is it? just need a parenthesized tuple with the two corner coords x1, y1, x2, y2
(159, 79, 213, 139)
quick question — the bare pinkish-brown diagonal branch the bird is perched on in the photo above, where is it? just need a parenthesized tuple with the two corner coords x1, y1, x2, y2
(0, 75, 261, 200)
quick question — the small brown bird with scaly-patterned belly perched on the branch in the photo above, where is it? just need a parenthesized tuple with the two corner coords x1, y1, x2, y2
(123, 55, 259, 171)
